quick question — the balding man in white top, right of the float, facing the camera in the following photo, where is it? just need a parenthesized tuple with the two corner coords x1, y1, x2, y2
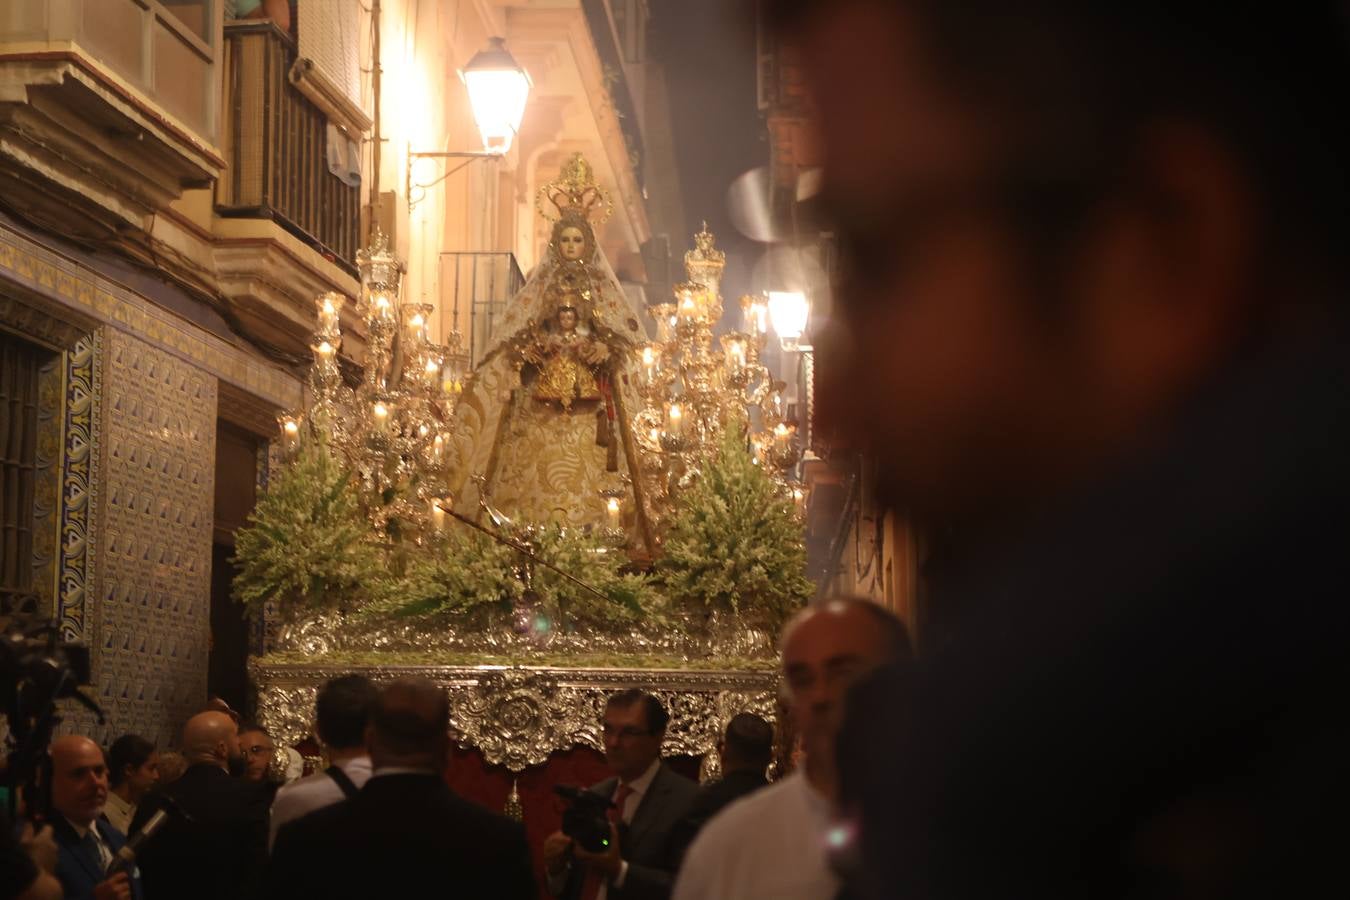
(674, 600, 910, 900)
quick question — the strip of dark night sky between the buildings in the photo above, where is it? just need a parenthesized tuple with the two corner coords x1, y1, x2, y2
(649, 0, 768, 305)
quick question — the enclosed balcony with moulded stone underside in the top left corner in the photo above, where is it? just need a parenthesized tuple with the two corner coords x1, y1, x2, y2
(0, 0, 224, 243)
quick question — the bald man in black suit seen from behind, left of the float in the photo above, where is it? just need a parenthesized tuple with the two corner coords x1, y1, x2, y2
(131, 711, 267, 900)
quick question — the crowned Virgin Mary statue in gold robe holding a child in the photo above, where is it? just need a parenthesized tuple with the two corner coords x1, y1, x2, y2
(451, 154, 647, 545)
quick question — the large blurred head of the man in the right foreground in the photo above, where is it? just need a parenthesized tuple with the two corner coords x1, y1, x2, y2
(770, 0, 1350, 519)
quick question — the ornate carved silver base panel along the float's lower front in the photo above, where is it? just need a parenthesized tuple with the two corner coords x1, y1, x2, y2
(251, 663, 778, 772)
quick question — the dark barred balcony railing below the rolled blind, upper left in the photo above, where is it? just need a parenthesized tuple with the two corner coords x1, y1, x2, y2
(216, 22, 360, 275)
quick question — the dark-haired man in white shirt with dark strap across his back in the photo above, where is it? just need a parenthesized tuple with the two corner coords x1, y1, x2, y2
(267, 675, 379, 850)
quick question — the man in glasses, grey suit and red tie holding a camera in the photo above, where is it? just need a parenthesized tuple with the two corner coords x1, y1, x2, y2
(544, 690, 698, 900)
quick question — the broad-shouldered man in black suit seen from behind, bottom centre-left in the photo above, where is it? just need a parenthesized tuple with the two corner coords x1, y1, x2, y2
(266, 679, 537, 900)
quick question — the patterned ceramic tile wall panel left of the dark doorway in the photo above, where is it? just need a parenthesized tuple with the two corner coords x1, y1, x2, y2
(92, 329, 217, 746)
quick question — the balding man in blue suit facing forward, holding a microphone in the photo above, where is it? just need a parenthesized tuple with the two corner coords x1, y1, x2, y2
(50, 734, 140, 900)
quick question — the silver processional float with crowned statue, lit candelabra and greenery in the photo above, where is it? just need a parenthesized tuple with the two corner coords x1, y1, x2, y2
(248, 154, 806, 788)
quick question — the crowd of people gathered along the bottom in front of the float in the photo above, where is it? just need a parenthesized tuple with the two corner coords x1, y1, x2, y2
(8, 600, 910, 900)
